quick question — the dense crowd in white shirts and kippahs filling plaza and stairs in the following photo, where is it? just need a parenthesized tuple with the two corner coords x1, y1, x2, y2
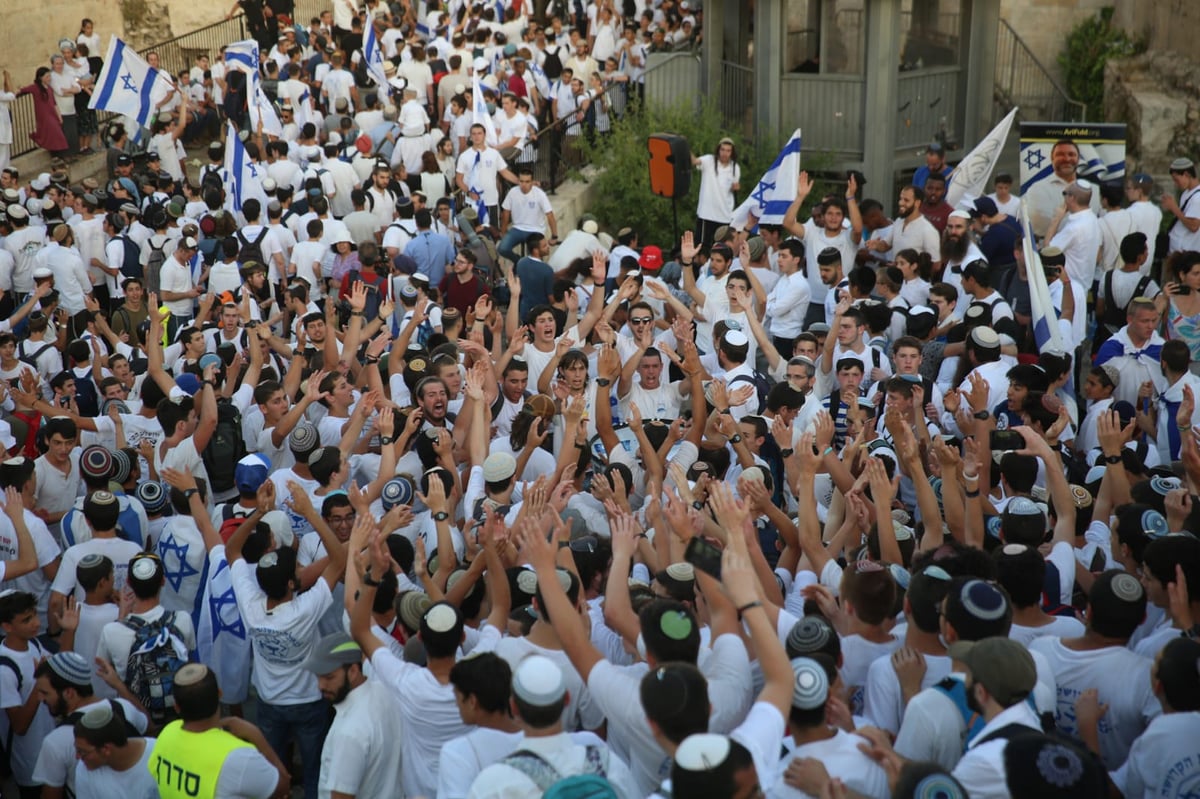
(0, 0, 1200, 799)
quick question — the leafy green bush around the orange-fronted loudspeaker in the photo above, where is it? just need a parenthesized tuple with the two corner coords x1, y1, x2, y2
(583, 98, 829, 250)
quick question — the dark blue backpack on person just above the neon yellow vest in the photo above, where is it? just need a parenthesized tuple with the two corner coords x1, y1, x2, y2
(121, 611, 187, 726)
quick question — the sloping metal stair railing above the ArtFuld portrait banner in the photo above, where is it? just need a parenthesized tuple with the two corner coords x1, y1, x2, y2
(995, 19, 1087, 122)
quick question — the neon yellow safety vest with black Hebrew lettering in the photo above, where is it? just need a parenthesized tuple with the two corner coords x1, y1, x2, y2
(149, 721, 252, 799)
